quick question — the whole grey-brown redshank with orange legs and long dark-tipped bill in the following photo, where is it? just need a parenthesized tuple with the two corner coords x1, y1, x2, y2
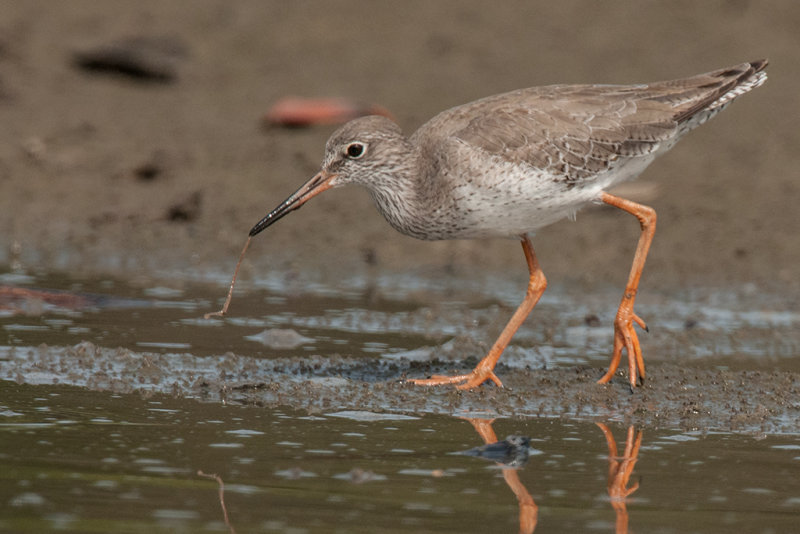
(248, 60, 767, 389)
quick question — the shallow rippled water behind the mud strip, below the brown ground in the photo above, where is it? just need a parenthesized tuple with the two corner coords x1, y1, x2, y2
(0, 275, 800, 371)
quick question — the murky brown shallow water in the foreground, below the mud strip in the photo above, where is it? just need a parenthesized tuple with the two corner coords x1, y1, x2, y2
(0, 382, 800, 532)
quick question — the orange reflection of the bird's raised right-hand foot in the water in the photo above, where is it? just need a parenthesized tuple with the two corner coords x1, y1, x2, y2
(596, 423, 642, 534)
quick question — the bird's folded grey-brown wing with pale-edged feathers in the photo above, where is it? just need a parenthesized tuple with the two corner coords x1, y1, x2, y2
(420, 61, 766, 183)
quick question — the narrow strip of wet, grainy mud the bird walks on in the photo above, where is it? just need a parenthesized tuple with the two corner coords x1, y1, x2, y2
(0, 342, 800, 434)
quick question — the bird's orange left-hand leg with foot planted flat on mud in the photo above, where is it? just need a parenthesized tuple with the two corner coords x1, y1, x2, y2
(409, 236, 547, 389)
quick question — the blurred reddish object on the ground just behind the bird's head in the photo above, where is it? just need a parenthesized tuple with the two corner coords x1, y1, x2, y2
(264, 96, 393, 127)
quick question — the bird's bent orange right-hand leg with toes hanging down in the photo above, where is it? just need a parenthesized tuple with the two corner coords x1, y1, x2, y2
(597, 193, 656, 388)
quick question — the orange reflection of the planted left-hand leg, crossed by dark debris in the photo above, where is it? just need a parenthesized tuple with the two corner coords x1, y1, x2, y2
(462, 418, 539, 534)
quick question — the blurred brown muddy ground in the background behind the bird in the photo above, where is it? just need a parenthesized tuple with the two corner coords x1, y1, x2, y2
(0, 0, 800, 293)
